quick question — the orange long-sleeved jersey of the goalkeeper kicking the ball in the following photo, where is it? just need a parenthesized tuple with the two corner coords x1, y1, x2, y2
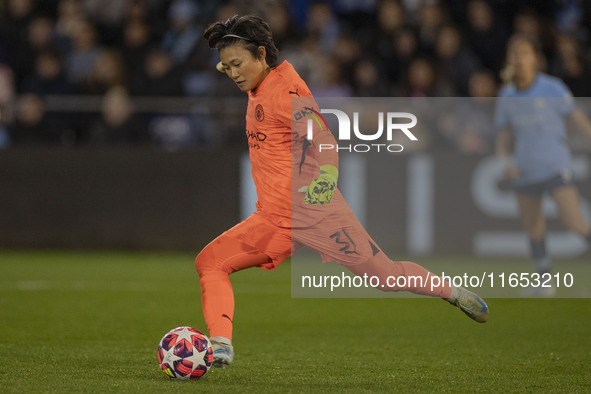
(246, 61, 344, 227)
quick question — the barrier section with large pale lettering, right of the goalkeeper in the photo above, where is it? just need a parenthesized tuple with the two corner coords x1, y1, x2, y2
(356, 150, 591, 257)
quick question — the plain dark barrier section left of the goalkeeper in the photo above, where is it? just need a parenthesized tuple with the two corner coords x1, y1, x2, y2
(0, 148, 240, 250)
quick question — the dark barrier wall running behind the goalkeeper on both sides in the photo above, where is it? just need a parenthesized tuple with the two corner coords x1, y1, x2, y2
(0, 148, 591, 257)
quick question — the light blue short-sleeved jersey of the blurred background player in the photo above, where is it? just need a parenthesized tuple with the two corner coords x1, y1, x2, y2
(495, 73, 575, 184)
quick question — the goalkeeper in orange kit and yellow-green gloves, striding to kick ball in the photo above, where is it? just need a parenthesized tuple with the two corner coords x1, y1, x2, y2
(195, 15, 488, 367)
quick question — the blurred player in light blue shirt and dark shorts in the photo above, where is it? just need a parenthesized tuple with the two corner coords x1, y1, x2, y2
(495, 36, 591, 296)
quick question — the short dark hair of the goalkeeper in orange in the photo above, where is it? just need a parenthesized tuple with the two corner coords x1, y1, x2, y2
(203, 15, 279, 67)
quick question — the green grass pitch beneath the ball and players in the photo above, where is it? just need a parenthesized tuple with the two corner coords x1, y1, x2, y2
(0, 251, 591, 393)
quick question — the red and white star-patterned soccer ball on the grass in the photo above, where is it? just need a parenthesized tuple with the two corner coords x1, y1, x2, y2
(158, 326, 213, 380)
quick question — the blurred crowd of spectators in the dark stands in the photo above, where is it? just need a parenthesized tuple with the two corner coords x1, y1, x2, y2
(0, 0, 591, 153)
